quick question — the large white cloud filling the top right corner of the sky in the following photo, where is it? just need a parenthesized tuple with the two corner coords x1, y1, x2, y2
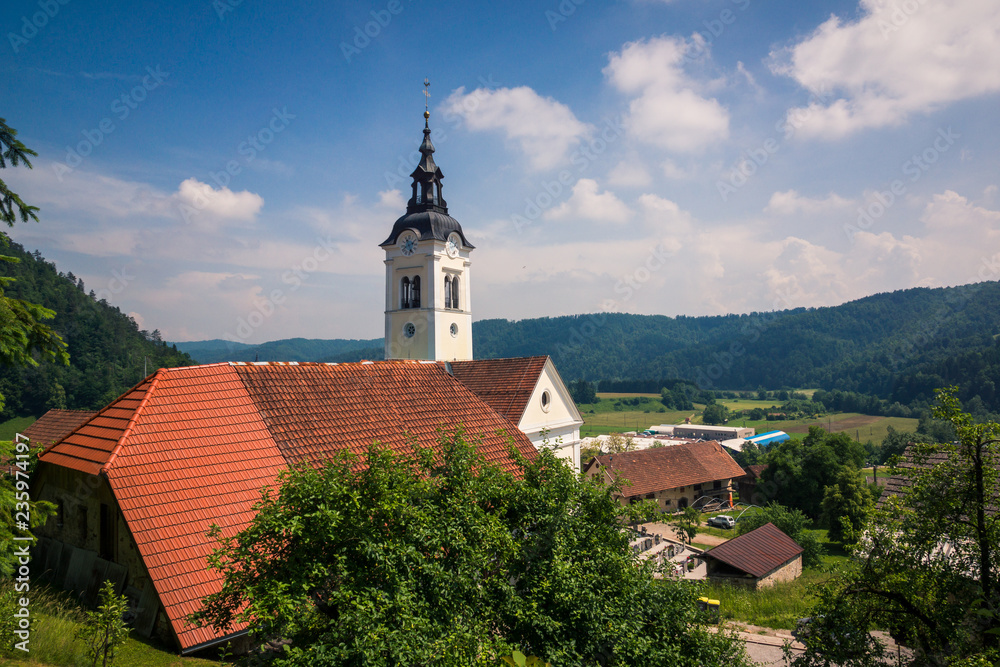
(771, 0, 1000, 139)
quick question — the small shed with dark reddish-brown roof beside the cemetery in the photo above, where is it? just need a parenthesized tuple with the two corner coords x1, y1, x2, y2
(701, 523, 802, 590)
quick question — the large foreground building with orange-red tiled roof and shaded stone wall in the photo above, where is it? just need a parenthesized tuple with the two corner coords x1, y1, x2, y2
(32, 361, 537, 653)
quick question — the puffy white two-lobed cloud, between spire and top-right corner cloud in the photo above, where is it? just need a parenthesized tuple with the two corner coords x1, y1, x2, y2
(604, 36, 729, 152)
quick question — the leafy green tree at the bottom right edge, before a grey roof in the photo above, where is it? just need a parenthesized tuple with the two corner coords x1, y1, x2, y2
(798, 389, 1000, 665)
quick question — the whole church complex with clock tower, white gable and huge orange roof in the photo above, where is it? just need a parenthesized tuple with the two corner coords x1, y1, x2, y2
(28, 103, 583, 654)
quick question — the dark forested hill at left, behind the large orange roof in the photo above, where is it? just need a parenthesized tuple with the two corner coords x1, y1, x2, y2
(0, 243, 194, 420)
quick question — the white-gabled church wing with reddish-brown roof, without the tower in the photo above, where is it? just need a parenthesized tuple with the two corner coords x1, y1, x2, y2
(449, 355, 583, 471)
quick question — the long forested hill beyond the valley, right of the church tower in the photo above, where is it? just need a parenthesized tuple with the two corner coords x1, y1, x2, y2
(473, 282, 1000, 412)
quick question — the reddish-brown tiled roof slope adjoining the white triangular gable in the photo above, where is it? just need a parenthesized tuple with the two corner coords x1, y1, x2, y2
(450, 356, 548, 424)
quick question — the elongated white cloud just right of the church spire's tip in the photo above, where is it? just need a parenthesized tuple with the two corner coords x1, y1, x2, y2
(444, 86, 591, 170)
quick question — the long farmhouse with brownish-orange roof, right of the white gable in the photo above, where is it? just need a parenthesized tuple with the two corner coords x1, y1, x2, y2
(584, 441, 743, 512)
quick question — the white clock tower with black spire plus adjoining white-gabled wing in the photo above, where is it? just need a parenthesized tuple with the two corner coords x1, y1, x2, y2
(380, 111, 583, 471)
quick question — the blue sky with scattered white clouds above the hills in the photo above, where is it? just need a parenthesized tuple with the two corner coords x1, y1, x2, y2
(0, 0, 1000, 343)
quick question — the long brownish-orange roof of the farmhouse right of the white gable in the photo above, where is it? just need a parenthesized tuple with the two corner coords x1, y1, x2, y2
(587, 441, 743, 496)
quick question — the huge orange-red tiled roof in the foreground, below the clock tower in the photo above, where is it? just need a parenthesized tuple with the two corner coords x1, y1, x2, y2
(41, 361, 536, 649)
